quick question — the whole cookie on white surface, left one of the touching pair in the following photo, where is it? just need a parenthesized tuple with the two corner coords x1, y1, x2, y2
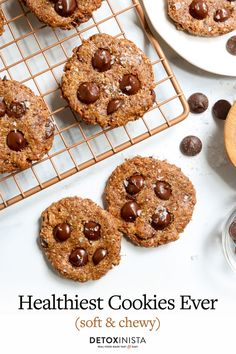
(40, 197, 121, 282)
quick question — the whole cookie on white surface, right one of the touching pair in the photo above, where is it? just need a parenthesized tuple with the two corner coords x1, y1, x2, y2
(105, 156, 196, 247)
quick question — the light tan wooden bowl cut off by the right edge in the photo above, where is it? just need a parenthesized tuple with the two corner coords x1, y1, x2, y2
(224, 102, 236, 167)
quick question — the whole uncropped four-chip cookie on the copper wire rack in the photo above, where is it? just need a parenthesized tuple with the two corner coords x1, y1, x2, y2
(62, 34, 155, 127)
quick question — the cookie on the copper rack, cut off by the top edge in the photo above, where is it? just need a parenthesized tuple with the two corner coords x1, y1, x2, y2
(22, 0, 102, 29)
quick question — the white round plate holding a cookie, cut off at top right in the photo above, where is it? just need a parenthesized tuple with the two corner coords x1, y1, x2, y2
(143, 0, 236, 76)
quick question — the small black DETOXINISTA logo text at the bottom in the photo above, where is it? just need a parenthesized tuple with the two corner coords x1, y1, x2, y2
(89, 337, 146, 349)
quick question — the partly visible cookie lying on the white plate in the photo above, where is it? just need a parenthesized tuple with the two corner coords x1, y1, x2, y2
(168, 0, 236, 37)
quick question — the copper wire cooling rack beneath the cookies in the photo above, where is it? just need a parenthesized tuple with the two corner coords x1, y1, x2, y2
(0, 0, 188, 210)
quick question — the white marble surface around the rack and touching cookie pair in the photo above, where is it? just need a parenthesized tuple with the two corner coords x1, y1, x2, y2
(0, 1, 236, 354)
